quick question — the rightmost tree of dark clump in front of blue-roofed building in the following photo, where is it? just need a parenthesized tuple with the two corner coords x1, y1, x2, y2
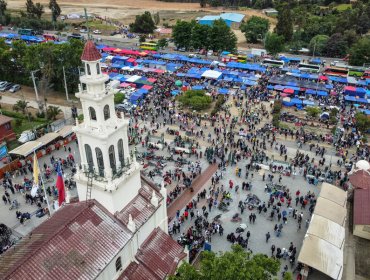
(209, 19, 238, 52)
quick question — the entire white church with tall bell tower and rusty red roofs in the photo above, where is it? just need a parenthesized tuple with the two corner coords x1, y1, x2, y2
(0, 41, 187, 280)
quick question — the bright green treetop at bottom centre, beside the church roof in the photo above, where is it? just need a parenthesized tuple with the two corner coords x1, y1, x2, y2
(170, 245, 280, 280)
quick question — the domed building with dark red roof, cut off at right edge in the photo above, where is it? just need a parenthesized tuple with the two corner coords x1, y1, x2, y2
(349, 160, 370, 240)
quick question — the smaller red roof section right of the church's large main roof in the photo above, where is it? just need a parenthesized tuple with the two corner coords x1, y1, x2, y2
(136, 228, 186, 279)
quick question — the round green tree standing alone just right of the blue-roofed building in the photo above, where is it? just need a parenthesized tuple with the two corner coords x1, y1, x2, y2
(240, 16, 270, 43)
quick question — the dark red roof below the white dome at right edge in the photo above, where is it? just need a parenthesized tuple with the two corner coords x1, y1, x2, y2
(353, 189, 370, 225)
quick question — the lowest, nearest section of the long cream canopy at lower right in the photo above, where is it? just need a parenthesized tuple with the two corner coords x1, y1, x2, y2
(298, 234, 343, 279)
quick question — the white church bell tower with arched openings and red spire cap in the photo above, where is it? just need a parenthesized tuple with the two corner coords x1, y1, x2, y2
(74, 41, 141, 214)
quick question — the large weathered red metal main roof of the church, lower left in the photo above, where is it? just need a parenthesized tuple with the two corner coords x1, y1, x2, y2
(0, 200, 132, 280)
